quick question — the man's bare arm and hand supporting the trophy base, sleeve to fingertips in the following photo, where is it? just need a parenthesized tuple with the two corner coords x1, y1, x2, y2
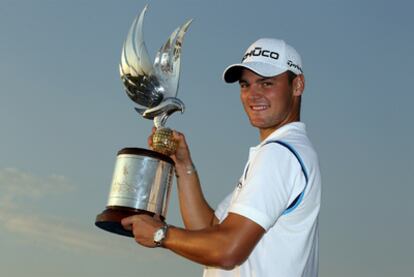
(121, 213, 265, 269)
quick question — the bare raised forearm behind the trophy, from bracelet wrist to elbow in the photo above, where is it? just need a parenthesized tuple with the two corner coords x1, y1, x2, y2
(176, 163, 214, 230)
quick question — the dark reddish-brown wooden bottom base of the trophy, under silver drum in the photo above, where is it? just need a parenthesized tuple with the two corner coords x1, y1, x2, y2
(95, 206, 165, 237)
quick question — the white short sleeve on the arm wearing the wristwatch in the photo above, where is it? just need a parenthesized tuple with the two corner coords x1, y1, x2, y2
(229, 144, 302, 231)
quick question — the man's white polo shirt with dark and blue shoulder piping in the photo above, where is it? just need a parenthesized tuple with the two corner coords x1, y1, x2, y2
(203, 122, 321, 277)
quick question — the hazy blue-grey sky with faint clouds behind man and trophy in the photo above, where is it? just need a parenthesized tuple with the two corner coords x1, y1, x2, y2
(0, 0, 414, 277)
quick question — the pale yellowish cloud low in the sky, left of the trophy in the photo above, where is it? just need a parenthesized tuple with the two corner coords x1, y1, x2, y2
(0, 168, 131, 253)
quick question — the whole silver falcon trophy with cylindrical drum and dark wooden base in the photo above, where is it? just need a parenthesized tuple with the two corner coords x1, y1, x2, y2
(95, 6, 192, 237)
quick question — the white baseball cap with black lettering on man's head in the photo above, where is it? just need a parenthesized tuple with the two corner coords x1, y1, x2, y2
(223, 38, 303, 83)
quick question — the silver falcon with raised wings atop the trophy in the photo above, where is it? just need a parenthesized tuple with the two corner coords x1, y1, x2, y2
(119, 6, 192, 128)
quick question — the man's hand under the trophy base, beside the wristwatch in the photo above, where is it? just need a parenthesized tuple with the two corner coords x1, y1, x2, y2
(121, 214, 164, 247)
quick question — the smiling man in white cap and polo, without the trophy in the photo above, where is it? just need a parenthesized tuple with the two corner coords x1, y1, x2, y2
(122, 39, 321, 277)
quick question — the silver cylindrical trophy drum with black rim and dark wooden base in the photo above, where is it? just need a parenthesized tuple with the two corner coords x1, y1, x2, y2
(95, 148, 174, 237)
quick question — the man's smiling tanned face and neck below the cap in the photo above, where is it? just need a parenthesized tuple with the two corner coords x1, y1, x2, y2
(239, 69, 304, 140)
